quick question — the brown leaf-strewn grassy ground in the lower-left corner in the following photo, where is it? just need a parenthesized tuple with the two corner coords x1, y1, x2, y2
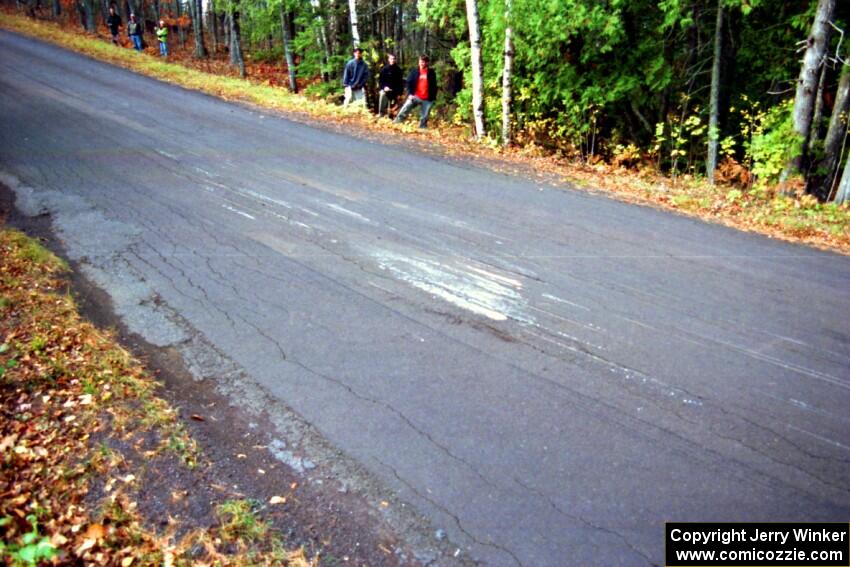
(0, 228, 318, 567)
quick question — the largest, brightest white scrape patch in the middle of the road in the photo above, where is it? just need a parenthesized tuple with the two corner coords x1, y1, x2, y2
(371, 250, 533, 323)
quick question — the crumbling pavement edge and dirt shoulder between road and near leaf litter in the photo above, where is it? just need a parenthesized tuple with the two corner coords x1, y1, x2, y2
(0, 179, 474, 566)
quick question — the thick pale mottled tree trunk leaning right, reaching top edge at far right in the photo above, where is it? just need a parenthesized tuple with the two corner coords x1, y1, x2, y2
(782, 0, 835, 191)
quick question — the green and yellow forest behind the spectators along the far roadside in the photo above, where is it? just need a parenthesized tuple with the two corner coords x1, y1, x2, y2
(13, 0, 850, 204)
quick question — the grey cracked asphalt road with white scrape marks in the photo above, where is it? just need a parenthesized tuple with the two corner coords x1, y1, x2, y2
(0, 32, 850, 566)
